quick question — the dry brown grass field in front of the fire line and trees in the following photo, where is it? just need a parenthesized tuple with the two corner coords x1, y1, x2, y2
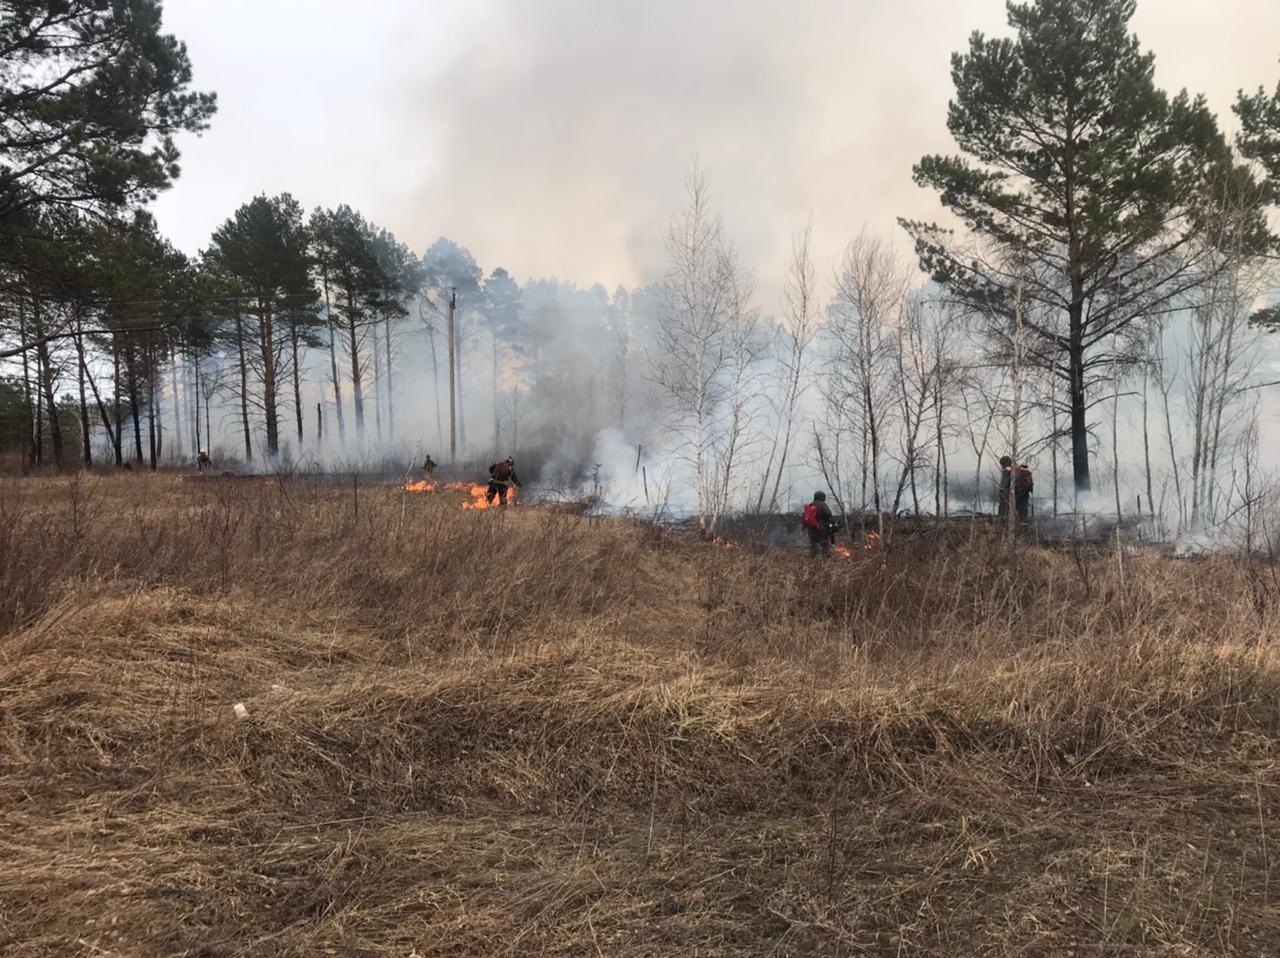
(0, 476, 1280, 955)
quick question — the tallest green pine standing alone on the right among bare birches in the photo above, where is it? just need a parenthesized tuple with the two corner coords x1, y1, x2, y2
(902, 0, 1259, 491)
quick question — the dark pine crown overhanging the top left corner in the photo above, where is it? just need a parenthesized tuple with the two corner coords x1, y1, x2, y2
(0, 0, 216, 223)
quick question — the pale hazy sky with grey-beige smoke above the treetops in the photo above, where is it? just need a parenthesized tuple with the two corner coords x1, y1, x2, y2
(159, 0, 1280, 307)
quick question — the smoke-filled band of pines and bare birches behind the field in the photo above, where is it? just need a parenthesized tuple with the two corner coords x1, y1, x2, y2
(0, 0, 1280, 545)
